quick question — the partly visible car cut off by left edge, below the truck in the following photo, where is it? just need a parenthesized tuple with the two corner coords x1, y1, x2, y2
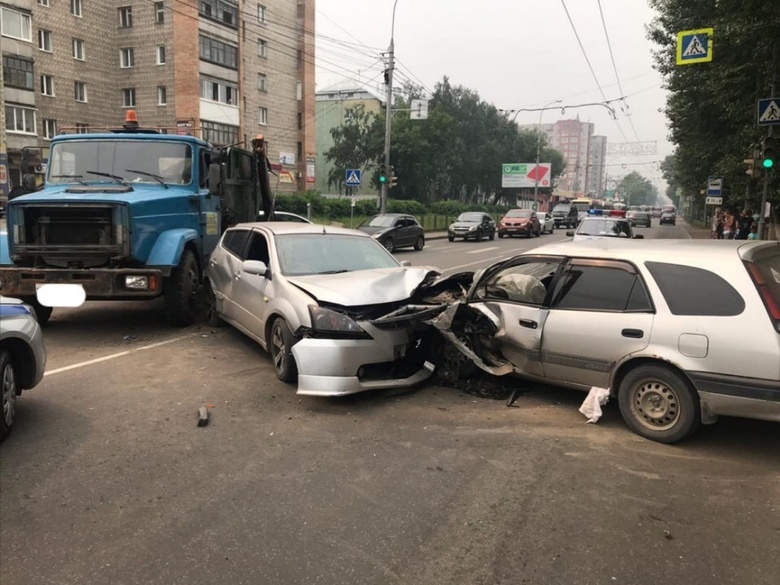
(0, 296, 46, 441)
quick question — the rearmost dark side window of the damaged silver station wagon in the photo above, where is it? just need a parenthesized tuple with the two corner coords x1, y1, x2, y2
(645, 262, 745, 317)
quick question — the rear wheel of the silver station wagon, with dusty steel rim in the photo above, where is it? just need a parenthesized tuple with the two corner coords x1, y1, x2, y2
(618, 365, 701, 443)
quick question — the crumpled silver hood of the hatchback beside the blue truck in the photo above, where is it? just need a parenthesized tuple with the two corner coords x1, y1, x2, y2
(287, 267, 440, 307)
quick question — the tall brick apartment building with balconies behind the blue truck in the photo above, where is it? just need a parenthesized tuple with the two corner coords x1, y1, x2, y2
(0, 0, 316, 196)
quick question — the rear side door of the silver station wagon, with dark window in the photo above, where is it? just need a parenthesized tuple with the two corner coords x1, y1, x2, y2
(542, 259, 655, 388)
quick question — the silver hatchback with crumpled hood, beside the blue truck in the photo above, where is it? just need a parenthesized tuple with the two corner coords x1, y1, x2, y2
(204, 222, 448, 396)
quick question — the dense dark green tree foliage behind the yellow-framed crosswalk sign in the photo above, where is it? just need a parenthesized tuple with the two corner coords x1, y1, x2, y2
(648, 0, 780, 208)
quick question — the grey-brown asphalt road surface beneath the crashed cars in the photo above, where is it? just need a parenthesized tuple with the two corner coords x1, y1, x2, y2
(0, 220, 780, 585)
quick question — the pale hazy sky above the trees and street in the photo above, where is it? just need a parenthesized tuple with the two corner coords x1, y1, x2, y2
(316, 0, 672, 192)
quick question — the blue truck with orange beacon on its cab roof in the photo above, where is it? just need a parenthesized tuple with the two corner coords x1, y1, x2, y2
(0, 112, 273, 326)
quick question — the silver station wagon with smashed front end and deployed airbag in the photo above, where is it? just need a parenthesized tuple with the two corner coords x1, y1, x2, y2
(444, 238, 780, 443)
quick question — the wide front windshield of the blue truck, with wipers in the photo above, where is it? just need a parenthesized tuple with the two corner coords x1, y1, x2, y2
(48, 140, 192, 185)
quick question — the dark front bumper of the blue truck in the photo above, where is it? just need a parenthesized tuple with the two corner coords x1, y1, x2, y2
(0, 266, 163, 300)
